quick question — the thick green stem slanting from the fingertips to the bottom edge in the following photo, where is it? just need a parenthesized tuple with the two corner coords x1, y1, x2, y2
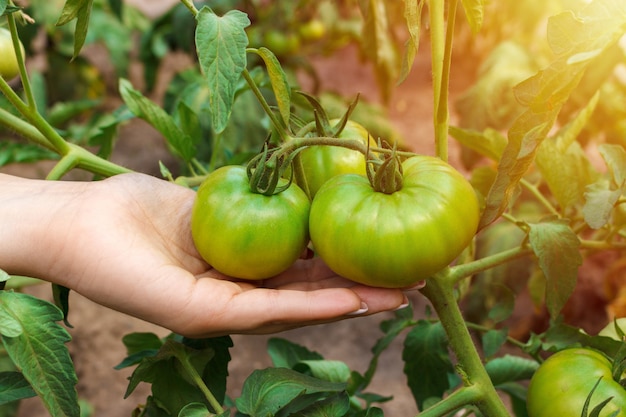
(421, 270, 510, 417)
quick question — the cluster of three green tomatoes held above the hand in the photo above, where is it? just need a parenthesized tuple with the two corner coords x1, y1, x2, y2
(191, 124, 479, 288)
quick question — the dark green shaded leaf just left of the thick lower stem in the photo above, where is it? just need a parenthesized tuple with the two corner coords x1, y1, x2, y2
(402, 320, 454, 410)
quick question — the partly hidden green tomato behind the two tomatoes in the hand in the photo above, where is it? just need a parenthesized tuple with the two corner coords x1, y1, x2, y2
(299, 120, 376, 197)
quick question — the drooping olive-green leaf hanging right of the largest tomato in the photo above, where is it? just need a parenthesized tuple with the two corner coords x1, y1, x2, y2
(529, 218, 582, 318)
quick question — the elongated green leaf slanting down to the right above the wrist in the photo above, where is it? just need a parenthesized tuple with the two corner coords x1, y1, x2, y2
(120, 79, 196, 162)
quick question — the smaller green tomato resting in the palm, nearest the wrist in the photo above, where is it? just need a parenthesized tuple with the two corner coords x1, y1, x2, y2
(191, 166, 310, 279)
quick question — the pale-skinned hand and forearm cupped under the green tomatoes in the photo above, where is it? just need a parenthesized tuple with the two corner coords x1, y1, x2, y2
(0, 174, 420, 337)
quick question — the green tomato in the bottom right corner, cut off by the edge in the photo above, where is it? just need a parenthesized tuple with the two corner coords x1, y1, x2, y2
(527, 348, 626, 417)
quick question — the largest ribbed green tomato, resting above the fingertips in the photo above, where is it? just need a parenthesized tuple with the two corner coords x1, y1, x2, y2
(309, 156, 479, 288)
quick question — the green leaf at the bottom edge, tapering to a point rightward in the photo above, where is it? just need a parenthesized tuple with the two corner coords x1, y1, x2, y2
(235, 368, 346, 416)
